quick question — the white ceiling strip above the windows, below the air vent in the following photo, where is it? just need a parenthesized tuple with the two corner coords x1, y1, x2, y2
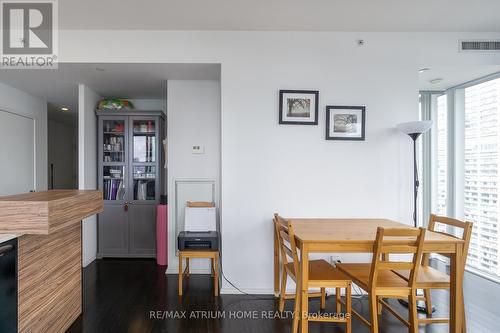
(419, 65, 500, 91)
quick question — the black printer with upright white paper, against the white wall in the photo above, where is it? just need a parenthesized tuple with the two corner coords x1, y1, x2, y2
(177, 201, 219, 251)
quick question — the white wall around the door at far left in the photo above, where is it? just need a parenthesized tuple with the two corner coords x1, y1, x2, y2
(0, 83, 47, 191)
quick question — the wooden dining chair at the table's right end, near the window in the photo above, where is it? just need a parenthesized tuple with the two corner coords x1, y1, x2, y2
(395, 214, 473, 332)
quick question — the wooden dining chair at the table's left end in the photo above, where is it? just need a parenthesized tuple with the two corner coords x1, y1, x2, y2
(274, 214, 351, 333)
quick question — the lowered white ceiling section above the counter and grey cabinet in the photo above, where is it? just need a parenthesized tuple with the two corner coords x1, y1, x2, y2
(0, 63, 220, 120)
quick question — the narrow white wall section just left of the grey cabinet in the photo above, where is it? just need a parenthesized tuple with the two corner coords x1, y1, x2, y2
(78, 84, 101, 267)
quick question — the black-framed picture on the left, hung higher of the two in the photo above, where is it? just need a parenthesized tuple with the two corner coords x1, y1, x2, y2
(279, 90, 319, 125)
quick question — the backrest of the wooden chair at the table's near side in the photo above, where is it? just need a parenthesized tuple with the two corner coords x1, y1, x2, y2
(370, 227, 425, 289)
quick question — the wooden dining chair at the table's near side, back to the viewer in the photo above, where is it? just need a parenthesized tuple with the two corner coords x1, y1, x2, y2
(337, 227, 425, 333)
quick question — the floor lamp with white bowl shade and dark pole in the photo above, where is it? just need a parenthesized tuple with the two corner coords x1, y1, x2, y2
(397, 120, 435, 312)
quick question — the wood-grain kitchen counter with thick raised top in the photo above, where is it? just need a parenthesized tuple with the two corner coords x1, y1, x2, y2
(0, 190, 103, 332)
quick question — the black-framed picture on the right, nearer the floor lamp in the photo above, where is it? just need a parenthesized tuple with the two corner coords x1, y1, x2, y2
(326, 106, 365, 141)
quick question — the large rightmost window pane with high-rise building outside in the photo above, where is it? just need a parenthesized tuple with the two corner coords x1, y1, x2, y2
(463, 79, 500, 277)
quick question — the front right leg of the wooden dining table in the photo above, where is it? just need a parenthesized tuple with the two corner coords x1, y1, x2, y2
(450, 243, 464, 333)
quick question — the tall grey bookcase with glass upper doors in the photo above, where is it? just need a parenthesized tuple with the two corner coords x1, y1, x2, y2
(96, 110, 166, 258)
